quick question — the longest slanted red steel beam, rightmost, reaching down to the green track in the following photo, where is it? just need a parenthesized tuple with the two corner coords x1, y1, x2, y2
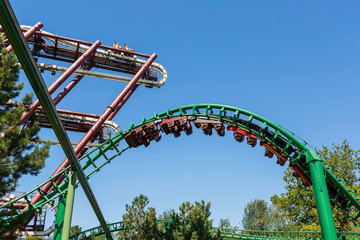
(31, 53, 157, 203)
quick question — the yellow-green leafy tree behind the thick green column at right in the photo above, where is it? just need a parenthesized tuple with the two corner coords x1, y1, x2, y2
(271, 140, 360, 231)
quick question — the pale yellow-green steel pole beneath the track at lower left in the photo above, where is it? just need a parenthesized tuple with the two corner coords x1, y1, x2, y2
(61, 171, 77, 240)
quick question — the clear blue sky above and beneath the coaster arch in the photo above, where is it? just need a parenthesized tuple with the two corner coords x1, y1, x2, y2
(10, 0, 360, 229)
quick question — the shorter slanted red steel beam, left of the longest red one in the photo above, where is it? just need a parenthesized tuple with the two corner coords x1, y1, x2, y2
(20, 41, 100, 124)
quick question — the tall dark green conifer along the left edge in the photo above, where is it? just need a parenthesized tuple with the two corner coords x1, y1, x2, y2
(0, 38, 49, 238)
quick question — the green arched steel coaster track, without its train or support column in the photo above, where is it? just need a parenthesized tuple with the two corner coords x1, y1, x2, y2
(0, 104, 360, 232)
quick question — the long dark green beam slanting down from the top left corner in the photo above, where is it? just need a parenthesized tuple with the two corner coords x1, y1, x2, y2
(0, 0, 112, 239)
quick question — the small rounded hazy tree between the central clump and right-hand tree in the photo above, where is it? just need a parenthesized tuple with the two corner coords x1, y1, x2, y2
(242, 199, 271, 231)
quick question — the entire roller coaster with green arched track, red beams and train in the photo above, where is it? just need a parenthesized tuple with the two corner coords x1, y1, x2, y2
(0, 1, 360, 239)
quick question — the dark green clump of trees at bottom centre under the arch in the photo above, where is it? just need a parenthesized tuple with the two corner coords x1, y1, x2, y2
(117, 195, 222, 240)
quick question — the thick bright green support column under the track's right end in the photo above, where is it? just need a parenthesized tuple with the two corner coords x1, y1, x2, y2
(306, 150, 337, 240)
